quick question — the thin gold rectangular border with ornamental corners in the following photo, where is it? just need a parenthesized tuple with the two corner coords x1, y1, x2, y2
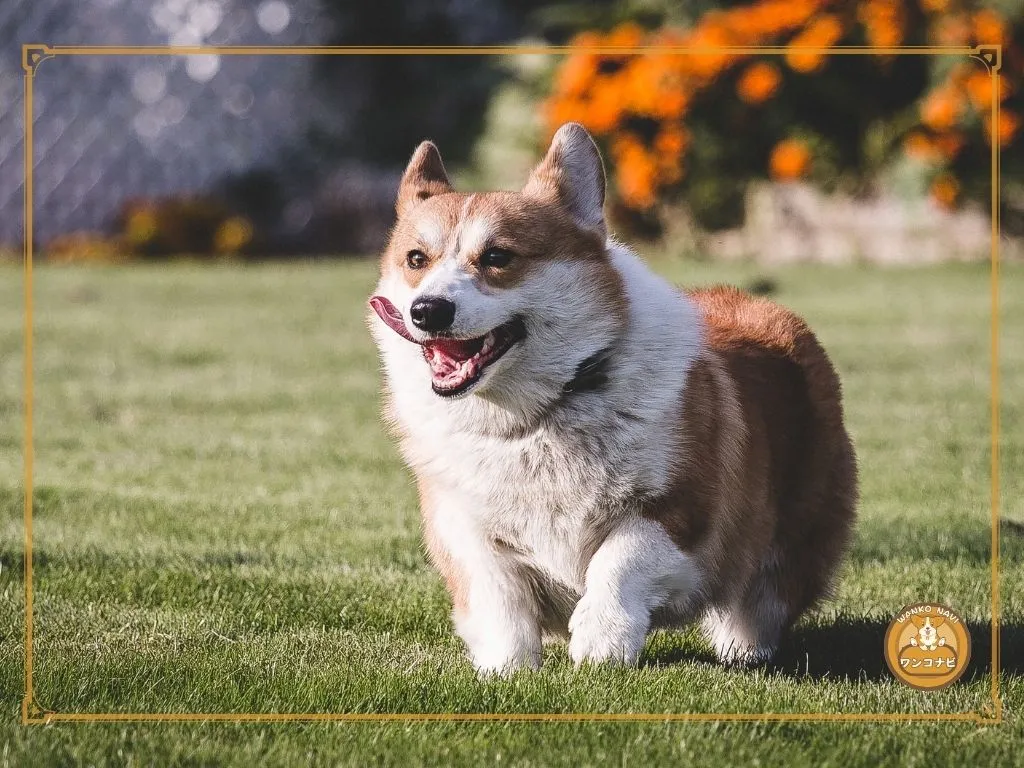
(22, 44, 1002, 725)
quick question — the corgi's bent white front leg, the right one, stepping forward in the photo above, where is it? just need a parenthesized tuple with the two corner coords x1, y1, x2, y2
(569, 517, 697, 665)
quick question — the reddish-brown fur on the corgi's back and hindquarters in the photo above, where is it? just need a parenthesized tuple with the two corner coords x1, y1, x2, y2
(644, 287, 857, 621)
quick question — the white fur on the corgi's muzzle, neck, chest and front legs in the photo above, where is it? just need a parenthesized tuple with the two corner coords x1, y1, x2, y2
(373, 231, 716, 672)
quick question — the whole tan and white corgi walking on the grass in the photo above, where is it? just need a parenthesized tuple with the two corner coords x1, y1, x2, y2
(369, 124, 857, 673)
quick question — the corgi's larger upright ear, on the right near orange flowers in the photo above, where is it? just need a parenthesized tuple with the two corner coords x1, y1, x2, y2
(522, 123, 606, 240)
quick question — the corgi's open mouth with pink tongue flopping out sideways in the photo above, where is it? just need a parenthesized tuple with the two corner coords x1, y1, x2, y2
(370, 296, 526, 397)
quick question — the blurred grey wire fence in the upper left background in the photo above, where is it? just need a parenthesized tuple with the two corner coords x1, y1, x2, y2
(0, 0, 348, 249)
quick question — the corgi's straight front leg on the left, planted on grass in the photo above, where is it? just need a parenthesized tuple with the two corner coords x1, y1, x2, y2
(420, 481, 542, 674)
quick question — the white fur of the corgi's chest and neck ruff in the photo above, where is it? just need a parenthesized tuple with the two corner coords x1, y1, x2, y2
(382, 243, 701, 593)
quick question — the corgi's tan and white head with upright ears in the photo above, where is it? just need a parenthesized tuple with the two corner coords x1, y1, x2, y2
(370, 124, 626, 411)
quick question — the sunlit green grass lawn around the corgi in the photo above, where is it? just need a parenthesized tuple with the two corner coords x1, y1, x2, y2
(0, 261, 1024, 766)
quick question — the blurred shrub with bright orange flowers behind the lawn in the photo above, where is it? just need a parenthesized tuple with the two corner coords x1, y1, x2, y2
(544, 0, 1024, 227)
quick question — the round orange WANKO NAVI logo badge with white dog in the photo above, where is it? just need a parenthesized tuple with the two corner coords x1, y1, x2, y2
(885, 603, 971, 690)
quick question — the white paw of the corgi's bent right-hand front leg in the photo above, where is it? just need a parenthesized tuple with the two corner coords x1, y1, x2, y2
(569, 595, 648, 665)
